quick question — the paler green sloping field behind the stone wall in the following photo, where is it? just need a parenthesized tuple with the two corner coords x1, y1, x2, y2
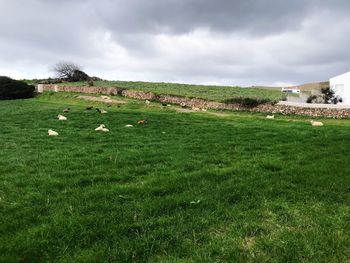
(57, 81, 286, 102)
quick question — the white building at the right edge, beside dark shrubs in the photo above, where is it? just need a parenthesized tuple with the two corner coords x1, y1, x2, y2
(329, 71, 350, 105)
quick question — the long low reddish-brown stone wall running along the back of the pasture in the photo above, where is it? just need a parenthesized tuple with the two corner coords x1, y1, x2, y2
(39, 85, 350, 118)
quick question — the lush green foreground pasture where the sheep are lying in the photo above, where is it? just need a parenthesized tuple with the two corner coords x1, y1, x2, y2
(0, 93, 350, 262)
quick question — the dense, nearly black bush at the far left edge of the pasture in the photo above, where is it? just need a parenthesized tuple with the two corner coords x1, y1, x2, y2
(0, 76, 35, 100)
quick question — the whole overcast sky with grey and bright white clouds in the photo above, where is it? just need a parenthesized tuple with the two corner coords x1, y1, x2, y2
(0, 0, 350, 86)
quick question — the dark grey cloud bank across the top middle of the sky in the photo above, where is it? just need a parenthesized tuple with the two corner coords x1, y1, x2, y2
(96, 0, 312, 35)
